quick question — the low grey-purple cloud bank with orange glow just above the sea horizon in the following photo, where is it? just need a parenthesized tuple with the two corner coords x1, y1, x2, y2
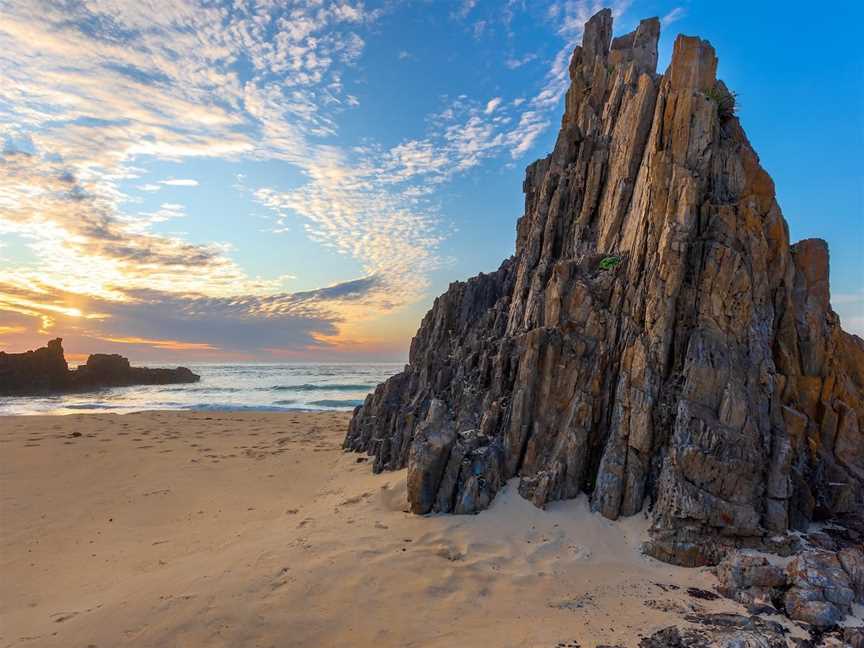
(0, 275, 384, 358)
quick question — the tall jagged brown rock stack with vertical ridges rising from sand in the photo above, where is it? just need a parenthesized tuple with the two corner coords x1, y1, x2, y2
(345, 10, 864, 565)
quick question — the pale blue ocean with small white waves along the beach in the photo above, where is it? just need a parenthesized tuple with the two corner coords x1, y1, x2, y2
(0, 363, 404, 415)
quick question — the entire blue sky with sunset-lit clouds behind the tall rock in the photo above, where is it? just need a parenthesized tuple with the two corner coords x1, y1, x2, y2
(0, 0, 864, 362)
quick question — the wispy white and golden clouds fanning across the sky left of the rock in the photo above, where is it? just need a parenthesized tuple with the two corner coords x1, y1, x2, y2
(0, 0, 627, 360)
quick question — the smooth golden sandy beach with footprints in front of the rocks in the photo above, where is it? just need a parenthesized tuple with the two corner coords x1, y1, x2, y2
(0, 412, 796, 648)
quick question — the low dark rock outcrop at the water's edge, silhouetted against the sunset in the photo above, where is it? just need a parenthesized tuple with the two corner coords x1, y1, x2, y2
(0, 338, 201, 396)
